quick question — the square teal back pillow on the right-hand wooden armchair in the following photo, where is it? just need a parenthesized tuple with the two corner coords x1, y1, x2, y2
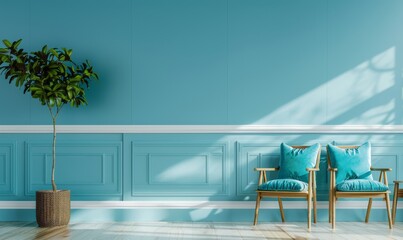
(327, 142, 372, 184)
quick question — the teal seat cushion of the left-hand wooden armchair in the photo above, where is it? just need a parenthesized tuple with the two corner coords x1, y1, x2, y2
(257, 179, 308, 192)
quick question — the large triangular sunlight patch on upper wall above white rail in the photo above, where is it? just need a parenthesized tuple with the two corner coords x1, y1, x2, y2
(252, 47, 396, 125)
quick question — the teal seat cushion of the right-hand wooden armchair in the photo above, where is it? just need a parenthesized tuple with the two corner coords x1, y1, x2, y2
(336, 179, 389, 192)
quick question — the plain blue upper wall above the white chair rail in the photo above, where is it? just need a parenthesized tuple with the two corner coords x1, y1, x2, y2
(0, 0, 403, 124)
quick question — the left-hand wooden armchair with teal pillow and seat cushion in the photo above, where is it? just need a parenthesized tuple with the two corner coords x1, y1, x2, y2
(253, 143, 321, 230)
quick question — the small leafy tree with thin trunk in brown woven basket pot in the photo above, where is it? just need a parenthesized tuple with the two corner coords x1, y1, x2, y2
(0, 39, 98, 227)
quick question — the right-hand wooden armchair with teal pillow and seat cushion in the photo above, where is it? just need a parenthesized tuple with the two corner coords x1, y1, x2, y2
(327, 142, 392, 229)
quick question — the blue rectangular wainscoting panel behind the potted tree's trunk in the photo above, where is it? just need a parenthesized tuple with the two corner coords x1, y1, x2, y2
(25, 142, 122, 200)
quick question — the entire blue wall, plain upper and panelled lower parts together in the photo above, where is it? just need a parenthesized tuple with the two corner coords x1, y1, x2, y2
(0, 0, 403, 221)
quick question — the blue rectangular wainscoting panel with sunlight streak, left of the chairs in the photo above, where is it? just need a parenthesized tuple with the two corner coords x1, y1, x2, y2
(131, 142, 229, 197)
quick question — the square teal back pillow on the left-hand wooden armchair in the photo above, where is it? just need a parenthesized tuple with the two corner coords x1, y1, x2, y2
(278, 143, 320, 182)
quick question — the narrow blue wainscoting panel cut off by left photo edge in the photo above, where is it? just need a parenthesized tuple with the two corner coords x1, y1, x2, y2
(0, 142, 17, 197)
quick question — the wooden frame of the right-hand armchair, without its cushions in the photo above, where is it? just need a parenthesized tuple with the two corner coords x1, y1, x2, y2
(327, 146, 392, 229)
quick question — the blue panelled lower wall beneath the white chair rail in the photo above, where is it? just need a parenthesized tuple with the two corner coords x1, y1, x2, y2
(0, 134, 403, 221)
